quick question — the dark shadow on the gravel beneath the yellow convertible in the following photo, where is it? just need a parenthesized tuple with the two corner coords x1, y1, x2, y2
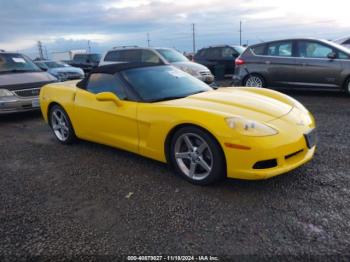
(73, 140, 309, 193)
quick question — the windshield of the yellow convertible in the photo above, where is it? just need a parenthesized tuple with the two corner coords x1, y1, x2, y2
(122, 66, 212, 102)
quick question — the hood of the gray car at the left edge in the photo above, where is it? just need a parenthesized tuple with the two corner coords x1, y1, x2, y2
(0, 72, 57, 90)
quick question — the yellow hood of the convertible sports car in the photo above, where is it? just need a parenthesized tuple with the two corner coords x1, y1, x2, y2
(162, 88, 293, 122)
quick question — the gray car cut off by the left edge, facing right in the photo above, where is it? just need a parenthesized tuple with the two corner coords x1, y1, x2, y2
(0, 51, 57, 114)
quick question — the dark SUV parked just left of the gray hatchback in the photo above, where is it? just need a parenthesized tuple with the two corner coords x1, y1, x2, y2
(194, 45, 245, 78)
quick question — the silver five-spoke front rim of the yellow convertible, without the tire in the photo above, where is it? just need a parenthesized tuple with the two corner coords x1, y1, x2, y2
(174, 133, 213, 181)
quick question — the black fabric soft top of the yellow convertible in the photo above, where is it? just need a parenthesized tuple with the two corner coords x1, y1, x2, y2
(77, 62, 166, 89)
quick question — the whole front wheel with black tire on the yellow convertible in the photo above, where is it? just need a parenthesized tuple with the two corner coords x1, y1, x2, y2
(169, 126, 226, 185)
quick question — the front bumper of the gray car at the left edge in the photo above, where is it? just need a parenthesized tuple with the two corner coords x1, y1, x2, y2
(0, 96, 40, 114)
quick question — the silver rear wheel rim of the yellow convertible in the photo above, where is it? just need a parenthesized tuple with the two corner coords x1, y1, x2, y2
(51, 108, 69, 142)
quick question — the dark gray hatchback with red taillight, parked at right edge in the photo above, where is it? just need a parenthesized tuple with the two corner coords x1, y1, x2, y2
(233, 38, 350, 94)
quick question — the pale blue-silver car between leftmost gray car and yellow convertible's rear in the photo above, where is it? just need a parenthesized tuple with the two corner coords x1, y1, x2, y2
(34, 60, 85, 81)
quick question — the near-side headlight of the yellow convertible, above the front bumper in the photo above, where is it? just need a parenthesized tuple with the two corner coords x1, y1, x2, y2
(225, 117, 278, 136)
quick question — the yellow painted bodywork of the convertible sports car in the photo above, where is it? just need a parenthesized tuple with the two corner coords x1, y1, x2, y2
(40, 81, 315, 179)
